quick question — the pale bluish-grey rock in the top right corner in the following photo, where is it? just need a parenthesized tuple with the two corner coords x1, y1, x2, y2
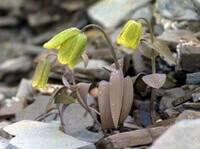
(156, 0, 200, 20)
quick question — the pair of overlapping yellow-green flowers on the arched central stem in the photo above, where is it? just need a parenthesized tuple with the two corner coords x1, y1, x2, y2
(43, 28, 87, 69)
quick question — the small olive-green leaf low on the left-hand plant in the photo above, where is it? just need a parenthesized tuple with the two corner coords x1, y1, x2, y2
(55, 94, 77, 105)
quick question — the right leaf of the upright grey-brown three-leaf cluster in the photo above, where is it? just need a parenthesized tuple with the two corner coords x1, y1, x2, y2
(119, 76, 134, 125)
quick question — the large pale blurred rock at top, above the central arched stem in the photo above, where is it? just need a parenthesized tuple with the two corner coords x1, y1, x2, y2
(88, 0, 151, 29)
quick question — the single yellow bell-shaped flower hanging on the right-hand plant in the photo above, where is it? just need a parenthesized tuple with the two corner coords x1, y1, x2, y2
(116, 20, 142, 50)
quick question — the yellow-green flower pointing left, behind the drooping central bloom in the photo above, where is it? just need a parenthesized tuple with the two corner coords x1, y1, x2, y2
(43, 28, 80, 50)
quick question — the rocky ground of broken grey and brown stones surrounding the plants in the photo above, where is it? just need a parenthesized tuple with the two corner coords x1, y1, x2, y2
(0, 0, 200, 149)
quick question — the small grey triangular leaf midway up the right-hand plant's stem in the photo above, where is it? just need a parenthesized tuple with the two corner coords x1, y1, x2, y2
(142, 73, 166, 89)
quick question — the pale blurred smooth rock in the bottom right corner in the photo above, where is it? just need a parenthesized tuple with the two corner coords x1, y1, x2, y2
(150, 119, 200, 149)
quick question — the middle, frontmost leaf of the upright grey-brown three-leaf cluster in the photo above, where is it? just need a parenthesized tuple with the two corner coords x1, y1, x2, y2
(109, 69, 124, 128)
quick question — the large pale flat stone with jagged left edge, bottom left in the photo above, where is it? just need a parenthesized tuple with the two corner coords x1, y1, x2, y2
(4, 120, 96, 149)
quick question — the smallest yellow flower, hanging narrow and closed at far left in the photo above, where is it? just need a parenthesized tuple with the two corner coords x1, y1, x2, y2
(32, 59, 51, 88)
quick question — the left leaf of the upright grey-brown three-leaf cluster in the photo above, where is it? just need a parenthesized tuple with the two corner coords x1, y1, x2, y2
(98, 81, 114, 129)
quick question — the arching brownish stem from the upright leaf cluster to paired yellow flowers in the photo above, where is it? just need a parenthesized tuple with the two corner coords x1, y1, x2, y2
(81, 24, 120, 70)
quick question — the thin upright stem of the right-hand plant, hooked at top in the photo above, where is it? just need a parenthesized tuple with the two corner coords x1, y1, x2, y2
(137, 17, 156, 124)
